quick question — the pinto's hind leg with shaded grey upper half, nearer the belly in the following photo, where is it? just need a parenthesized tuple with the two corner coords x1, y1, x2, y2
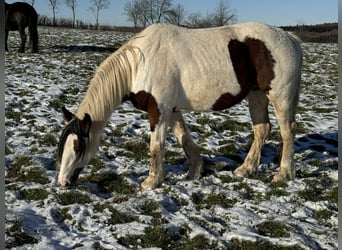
(234, 90, 271, 176)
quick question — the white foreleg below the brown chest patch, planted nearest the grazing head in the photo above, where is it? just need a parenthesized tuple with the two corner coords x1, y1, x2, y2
(141, 116, 168, 191)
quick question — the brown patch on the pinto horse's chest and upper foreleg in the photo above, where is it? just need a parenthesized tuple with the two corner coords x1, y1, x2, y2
(127, 91, 160, 131)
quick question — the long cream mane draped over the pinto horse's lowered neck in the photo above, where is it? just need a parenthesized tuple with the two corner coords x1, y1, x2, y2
(76, 44, 141, 121)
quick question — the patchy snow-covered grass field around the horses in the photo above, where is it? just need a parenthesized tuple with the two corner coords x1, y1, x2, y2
(5, 27, 338, 249)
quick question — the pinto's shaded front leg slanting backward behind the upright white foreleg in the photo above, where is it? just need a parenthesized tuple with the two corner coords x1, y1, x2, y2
(171, 112, 203, 179)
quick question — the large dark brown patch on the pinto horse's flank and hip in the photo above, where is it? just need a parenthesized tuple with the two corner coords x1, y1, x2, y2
(212, 37, 275, 110)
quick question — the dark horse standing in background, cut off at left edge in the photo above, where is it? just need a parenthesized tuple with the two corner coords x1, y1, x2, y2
(5, 2, 38, 53)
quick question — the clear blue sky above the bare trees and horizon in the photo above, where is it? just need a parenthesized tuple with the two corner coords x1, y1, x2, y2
(6, 0, 338, 26)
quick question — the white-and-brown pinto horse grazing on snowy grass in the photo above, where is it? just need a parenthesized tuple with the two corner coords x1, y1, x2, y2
(57, 23, 302, 190)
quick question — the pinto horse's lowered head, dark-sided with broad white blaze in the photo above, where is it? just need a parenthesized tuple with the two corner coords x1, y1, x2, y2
(57, 107, 91, 187)
